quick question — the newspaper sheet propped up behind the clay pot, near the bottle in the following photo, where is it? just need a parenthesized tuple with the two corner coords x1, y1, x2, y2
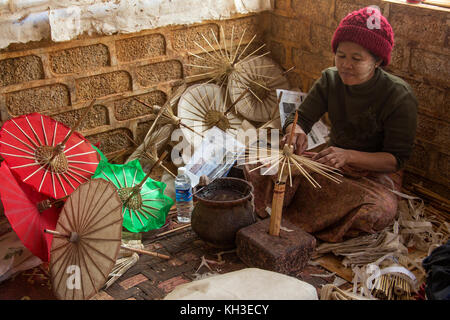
(185, 127, 245, 187)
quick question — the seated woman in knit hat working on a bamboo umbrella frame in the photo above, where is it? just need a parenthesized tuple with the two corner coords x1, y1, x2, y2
(246, 7, 417, 242)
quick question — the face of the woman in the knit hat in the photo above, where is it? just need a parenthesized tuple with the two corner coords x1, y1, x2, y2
(334, 42, 382, 86)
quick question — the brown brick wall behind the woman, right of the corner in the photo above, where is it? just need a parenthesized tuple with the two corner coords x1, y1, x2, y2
(262, 0, 450, 198)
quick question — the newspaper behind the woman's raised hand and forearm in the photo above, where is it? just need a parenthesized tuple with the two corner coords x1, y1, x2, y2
(277, 89, 330, 150)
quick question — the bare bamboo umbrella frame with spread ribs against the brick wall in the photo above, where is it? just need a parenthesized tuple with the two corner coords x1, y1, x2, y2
(186, 26, 270, 89)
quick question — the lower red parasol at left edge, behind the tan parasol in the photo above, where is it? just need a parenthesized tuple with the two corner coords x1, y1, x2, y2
(0, 161, 61, 262)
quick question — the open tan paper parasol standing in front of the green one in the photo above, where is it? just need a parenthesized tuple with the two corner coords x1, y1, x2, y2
(46, 179, 122, 300)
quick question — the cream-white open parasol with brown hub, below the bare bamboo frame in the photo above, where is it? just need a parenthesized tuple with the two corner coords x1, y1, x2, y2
(178, 84, 246, 138)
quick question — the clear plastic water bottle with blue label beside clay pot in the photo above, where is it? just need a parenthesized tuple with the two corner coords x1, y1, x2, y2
(175, 167, 193, 223)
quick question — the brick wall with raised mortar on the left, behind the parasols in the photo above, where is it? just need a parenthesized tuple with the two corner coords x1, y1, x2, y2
(0, 14, 262, 158)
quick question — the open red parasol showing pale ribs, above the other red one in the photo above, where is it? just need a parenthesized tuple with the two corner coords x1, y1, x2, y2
(0, 113, 99, 199)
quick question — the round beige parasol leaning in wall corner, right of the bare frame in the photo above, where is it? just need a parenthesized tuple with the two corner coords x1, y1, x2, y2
(228, 57, 290, 122)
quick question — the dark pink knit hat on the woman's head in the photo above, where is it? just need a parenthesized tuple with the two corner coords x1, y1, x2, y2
(331, 7, 394, 66)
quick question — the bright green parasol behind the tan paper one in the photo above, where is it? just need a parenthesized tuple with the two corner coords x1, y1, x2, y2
(92, 159, 173, 232)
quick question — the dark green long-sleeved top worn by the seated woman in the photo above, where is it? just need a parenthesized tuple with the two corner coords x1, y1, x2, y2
(283, 67, 417, 169)
